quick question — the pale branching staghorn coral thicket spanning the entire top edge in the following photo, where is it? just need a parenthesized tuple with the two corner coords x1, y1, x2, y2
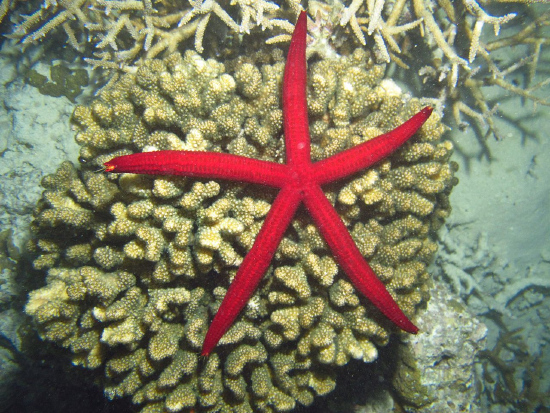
(6, 0, 550, 145)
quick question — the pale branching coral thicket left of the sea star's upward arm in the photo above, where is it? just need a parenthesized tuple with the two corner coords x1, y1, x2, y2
(2, 0, 300, 68)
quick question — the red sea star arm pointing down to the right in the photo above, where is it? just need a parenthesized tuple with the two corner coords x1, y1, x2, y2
(303, 185, 418, 334)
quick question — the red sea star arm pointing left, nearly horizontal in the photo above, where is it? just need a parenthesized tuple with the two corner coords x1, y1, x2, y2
(104, 151, 288, 188)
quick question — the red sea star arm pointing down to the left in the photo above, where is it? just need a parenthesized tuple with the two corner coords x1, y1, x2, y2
(201, 186, 301, 356)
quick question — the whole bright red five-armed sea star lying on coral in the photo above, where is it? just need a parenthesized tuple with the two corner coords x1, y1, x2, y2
(105, 12, 432, 356)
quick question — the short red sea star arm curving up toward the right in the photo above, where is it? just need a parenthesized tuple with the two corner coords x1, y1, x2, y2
(313, 106, 433, 185)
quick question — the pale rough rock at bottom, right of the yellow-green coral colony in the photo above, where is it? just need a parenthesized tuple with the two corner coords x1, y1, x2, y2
(393, 285, 487, 413)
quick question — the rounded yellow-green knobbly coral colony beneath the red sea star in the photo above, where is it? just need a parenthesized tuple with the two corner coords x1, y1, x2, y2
(26, 50, 455, 412)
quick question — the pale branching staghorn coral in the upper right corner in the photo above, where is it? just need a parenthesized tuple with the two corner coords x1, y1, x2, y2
(332, 0, 550, 138)
